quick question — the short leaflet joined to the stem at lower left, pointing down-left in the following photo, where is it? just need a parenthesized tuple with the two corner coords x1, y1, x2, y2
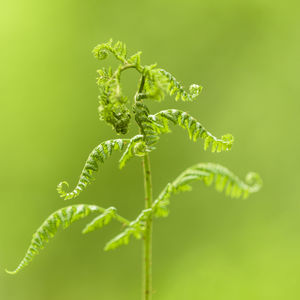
(104, 208, 152, 251)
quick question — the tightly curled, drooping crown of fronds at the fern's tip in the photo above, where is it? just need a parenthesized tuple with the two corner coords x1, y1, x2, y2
(93, 40, 202, 134)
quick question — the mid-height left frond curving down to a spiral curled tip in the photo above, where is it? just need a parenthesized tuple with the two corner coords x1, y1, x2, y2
(57, 139, 131, 200)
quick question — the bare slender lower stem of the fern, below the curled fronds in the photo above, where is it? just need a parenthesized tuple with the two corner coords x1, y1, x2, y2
(143, 154, 152, 300)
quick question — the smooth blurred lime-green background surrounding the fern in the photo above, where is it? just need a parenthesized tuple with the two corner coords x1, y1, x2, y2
(0, 0, 300, 300)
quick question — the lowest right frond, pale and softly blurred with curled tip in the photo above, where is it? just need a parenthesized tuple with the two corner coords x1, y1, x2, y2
(152, 163, 262, 217)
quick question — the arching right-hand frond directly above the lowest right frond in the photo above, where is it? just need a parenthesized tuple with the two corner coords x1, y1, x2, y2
(148, 109, 233, 152)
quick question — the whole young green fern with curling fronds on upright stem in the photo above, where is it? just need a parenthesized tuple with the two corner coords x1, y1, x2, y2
(7, 40, 262, 300)
